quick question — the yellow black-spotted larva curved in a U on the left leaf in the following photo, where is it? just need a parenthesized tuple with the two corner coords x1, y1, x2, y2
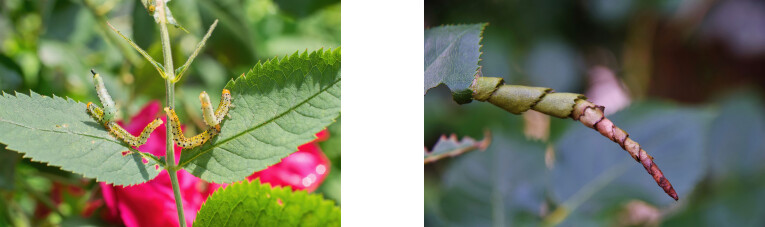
(87, 102, 162, 147)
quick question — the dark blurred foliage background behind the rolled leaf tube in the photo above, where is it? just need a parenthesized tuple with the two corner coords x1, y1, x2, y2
(424, 0, 765, 226)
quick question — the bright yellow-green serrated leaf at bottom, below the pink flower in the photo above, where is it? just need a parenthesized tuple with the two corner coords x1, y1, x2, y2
(194, 180, 340, 227)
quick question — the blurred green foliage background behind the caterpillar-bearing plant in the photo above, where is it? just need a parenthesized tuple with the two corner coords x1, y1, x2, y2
(0, 0, 340, 226)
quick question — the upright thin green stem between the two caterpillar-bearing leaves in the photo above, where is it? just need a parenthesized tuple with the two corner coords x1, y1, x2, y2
(157, 1, 186, 227)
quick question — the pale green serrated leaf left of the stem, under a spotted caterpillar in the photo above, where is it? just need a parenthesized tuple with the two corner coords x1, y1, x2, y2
(0, 92, 159, 185)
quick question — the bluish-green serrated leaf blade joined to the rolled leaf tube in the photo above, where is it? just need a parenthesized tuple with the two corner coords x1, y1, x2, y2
(425, 23, 486, 103)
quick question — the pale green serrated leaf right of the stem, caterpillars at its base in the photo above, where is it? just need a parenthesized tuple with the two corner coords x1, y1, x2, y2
(180, 48, 340, 182)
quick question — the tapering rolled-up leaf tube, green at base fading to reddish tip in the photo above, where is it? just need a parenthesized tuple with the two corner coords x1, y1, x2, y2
(470, 77, 678, 200)
